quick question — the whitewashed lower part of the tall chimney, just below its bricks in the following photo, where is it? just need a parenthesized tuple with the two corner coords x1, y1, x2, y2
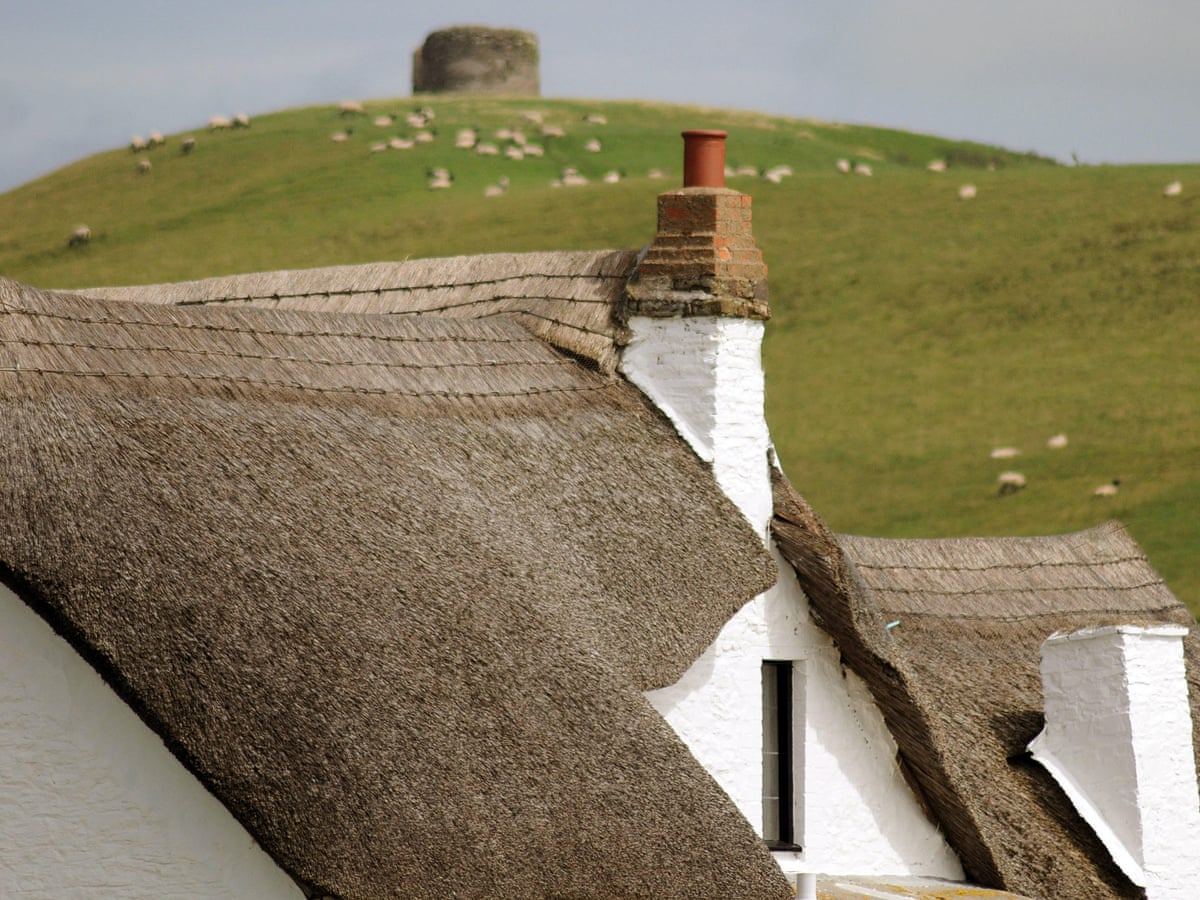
(620, 316, 774, 541)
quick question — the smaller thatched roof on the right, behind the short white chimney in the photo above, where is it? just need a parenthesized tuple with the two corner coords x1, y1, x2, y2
(773, 465, 1200, 898)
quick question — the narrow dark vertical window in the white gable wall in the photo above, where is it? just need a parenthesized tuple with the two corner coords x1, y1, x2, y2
(762, 660, 799, 850)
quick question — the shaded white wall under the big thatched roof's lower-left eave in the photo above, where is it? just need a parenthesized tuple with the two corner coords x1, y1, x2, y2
(0, 586, 304, 900)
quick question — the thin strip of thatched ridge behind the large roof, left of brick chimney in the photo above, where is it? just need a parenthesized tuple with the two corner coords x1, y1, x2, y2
(78, 250, 637, 373)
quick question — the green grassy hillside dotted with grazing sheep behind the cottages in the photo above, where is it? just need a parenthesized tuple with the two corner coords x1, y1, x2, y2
(0, 97, 1200, 611)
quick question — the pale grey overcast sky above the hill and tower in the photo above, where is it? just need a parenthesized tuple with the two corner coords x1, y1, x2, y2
(0, 0, 1200, 191)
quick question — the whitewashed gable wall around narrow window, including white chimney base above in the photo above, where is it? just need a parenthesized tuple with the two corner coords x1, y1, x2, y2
(622, 318, 964, 880)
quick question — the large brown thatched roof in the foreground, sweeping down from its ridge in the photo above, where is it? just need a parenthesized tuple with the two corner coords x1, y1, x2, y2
(0, 280, 788, 898)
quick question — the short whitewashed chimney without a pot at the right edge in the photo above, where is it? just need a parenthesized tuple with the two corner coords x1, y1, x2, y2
(1030, 625, 1200, 900)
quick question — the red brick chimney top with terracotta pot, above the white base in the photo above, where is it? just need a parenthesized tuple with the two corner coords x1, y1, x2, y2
(625, 131, 770, 319)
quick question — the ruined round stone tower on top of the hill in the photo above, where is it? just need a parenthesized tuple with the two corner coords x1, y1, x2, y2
(413, 25, 541, 97)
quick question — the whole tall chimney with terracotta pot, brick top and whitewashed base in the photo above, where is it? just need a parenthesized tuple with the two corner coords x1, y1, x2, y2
(620, 131, 772, 540)
